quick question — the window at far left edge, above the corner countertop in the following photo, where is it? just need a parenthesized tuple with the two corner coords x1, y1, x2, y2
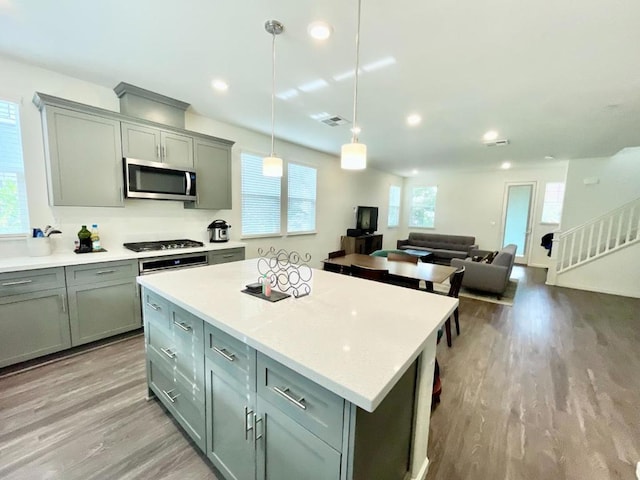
(0, 100, 29, 235)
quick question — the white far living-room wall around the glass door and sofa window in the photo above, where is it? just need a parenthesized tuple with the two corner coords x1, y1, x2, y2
(401, 162, 566, 267)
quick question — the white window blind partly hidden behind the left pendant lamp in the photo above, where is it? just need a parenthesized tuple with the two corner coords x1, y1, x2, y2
(241, 153, 281, 235)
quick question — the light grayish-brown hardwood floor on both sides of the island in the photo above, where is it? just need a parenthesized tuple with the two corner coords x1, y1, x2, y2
(0, 268, 640, 480)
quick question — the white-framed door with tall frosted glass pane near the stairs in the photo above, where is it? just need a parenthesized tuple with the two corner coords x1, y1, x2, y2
(502, 182, 536, 264)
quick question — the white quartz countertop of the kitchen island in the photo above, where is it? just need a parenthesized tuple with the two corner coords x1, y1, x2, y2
(138, 259, 458, 412)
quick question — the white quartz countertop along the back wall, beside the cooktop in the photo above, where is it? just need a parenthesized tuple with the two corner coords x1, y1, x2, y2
(0, 242, 246, 273)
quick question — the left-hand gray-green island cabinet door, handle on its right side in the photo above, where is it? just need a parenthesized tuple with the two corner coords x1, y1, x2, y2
(205, 359, 255, 480)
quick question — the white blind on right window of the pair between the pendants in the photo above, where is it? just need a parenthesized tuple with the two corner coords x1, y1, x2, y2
(287, 163, 317, 233)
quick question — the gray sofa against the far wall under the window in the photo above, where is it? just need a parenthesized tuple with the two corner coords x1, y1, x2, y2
(396, 232, 478, 265)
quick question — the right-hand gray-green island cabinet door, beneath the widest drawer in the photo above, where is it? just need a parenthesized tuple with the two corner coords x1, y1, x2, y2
(255, 397, 341, 480)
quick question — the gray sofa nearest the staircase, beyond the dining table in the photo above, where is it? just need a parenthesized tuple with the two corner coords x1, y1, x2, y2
(451, 244, 517, 298)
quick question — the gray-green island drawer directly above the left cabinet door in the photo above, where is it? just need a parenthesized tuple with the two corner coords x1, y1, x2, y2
(204, 324, 256, 392)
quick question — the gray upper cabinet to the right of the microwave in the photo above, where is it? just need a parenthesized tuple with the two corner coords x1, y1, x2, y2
(184, 137, 231, 210)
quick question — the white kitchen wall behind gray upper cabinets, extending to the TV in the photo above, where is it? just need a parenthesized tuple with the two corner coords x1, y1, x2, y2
(0, 56, 402, 266)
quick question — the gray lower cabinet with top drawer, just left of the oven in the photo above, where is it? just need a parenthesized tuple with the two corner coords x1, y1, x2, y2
(65, 260, 142, 346)
